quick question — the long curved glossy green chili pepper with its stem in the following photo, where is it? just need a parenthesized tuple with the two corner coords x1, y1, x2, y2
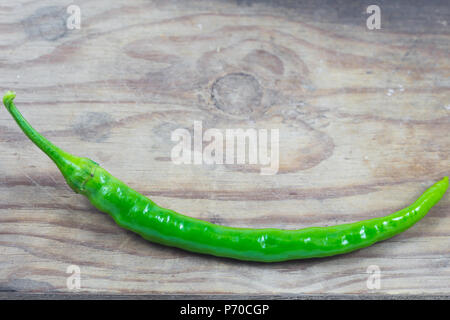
(3, 92, 448, 262)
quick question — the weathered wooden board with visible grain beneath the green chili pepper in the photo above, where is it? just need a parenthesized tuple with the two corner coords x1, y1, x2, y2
(0, 0, 450, 298)
